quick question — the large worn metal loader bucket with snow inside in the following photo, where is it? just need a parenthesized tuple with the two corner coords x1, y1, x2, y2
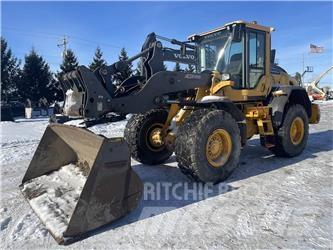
(20, 124, 143, 244)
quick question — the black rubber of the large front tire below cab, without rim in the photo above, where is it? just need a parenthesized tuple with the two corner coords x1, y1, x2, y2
(175, 110, 241, 183)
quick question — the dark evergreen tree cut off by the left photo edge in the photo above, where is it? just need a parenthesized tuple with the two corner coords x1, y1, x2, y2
(1, 37, 21, 101)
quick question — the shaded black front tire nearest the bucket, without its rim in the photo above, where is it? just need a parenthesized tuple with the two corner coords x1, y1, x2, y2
(124, 109, 173, 165)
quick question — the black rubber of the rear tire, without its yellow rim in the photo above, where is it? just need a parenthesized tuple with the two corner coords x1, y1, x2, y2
(269, 104, 309, 157)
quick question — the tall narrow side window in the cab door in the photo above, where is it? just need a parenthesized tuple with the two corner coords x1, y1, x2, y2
(248, 32, 265, 88)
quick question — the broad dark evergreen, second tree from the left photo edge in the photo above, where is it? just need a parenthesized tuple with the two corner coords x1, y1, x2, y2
(18, 49, 53, 102)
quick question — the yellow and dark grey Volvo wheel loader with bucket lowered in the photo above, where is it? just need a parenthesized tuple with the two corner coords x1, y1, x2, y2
(20, 21, 320, 244)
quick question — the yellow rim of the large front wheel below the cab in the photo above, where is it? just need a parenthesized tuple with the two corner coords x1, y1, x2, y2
(206, 129, 232, 168)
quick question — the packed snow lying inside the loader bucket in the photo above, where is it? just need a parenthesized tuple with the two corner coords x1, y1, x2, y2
(22, 164, 86, 238)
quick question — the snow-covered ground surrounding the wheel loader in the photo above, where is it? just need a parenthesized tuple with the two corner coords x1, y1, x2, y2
(0, 101, 333, 249)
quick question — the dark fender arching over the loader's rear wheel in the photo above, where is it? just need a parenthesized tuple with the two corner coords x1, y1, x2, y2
(268, 85, 312, 127)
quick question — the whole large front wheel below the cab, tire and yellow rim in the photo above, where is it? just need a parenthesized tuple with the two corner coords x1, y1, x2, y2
(175, 110, 241, 183)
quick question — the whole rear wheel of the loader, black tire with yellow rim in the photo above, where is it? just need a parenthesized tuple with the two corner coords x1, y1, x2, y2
(269, 104, 309, 157)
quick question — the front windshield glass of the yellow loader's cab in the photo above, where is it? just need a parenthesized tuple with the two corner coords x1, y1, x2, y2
(199, 30, 243, 85)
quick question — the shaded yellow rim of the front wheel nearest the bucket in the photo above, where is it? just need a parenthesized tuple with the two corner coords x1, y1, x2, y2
(146, 123, 164, 152)
